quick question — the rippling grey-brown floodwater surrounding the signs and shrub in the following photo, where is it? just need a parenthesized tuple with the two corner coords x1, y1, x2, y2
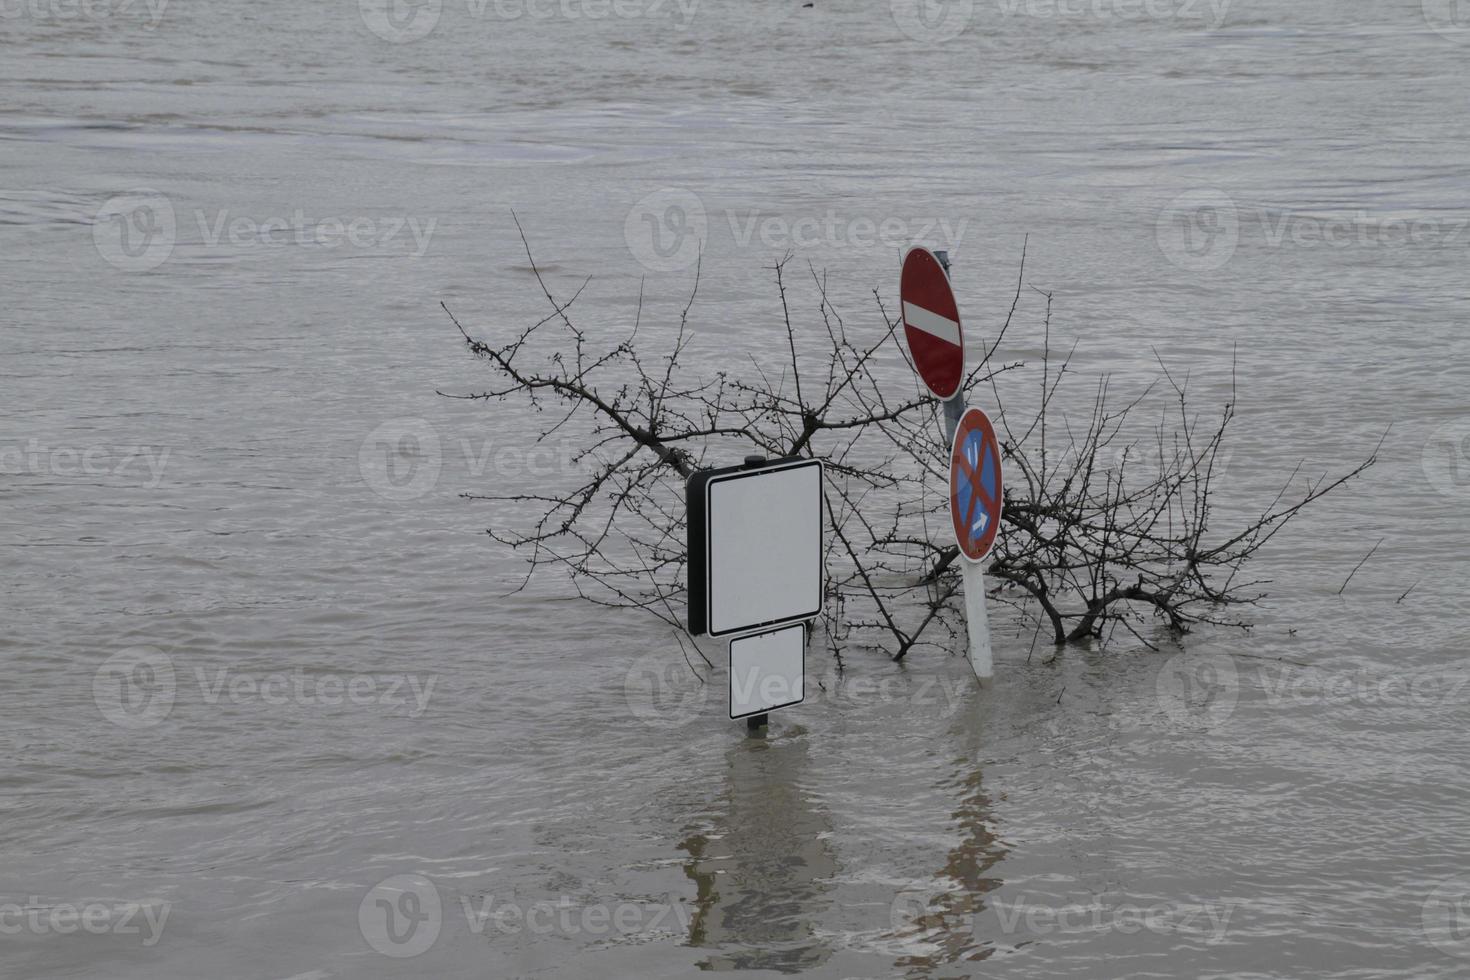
(0, 0, 1470, 980)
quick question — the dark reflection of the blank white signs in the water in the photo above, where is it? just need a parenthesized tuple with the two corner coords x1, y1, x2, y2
(679, 735, 836, 973)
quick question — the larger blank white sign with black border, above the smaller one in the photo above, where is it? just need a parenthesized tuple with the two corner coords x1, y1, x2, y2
(706, 461, 822, 636)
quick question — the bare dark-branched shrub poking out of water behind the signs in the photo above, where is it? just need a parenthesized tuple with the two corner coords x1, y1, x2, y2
(444, 226, 1376, 660)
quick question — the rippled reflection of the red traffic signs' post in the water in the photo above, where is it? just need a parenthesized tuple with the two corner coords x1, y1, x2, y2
(894, 711, 1005, 976)
